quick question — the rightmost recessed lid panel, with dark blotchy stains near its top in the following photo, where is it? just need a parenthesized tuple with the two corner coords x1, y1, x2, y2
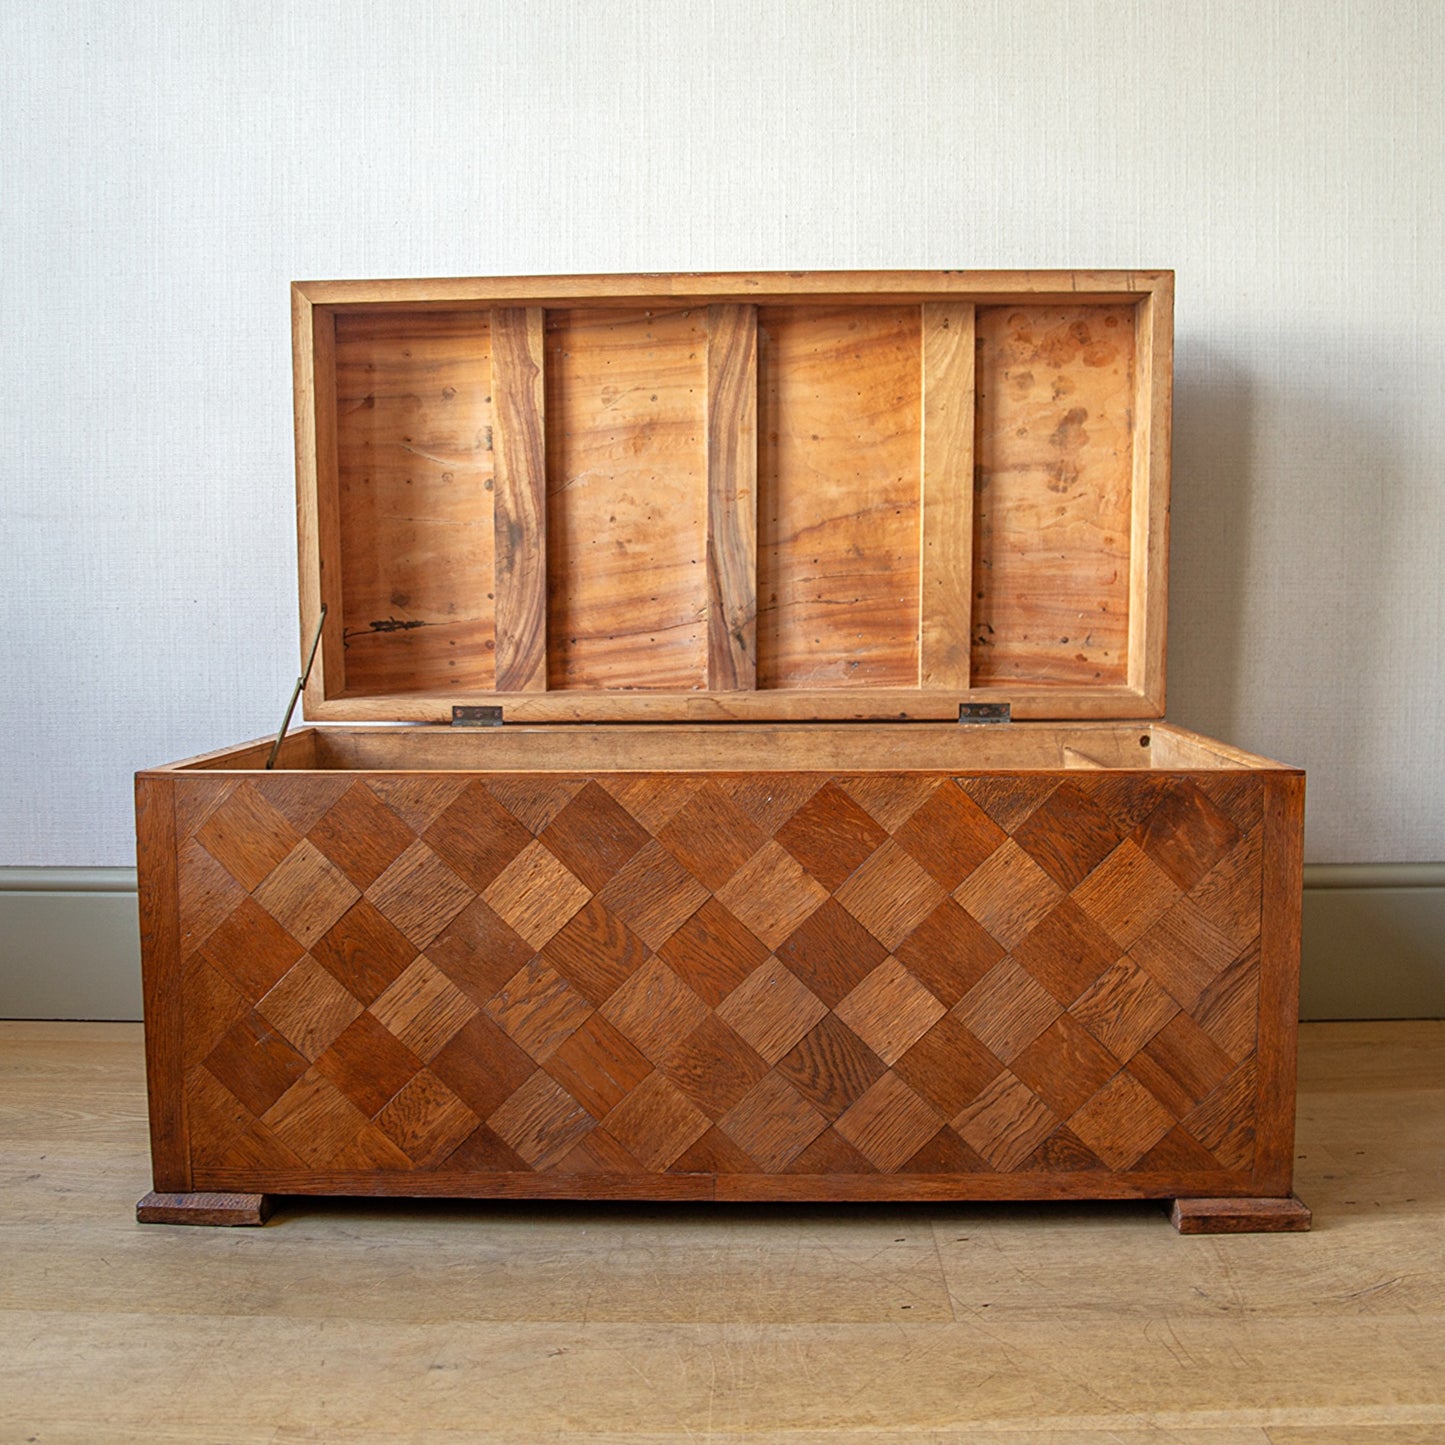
(972, 305, 1134, 686)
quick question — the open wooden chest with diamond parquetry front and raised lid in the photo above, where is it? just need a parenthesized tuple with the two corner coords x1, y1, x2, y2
(137, 272, 1308, 1230)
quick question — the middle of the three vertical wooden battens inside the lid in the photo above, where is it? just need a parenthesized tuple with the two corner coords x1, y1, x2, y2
(707, 306, 757, 692)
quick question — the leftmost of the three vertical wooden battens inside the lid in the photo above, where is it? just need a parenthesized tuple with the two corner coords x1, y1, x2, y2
(491, 306, 546, 692)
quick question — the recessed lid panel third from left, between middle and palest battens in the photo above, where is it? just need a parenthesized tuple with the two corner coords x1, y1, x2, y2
(757, 306, 922, 688)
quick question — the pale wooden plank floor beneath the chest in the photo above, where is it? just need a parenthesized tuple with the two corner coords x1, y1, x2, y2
(0, 1023, 1445, 1445)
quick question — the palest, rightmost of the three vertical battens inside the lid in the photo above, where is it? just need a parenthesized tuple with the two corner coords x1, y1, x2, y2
(918, 301, 974, 688)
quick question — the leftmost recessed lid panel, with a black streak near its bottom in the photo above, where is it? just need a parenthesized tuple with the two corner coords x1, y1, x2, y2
(335, 312, 497, 692)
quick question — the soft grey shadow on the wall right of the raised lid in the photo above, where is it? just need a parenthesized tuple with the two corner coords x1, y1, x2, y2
(1169, 342, 1410, 863)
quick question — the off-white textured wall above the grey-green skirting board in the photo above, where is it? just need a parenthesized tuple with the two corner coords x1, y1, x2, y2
(0, 0, 1445, 864)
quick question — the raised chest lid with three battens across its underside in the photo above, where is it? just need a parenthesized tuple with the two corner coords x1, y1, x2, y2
(293, 272, 1173, 721)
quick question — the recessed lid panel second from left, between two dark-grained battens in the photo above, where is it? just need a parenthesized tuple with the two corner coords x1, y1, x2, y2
(546, 308, 708, 689)
